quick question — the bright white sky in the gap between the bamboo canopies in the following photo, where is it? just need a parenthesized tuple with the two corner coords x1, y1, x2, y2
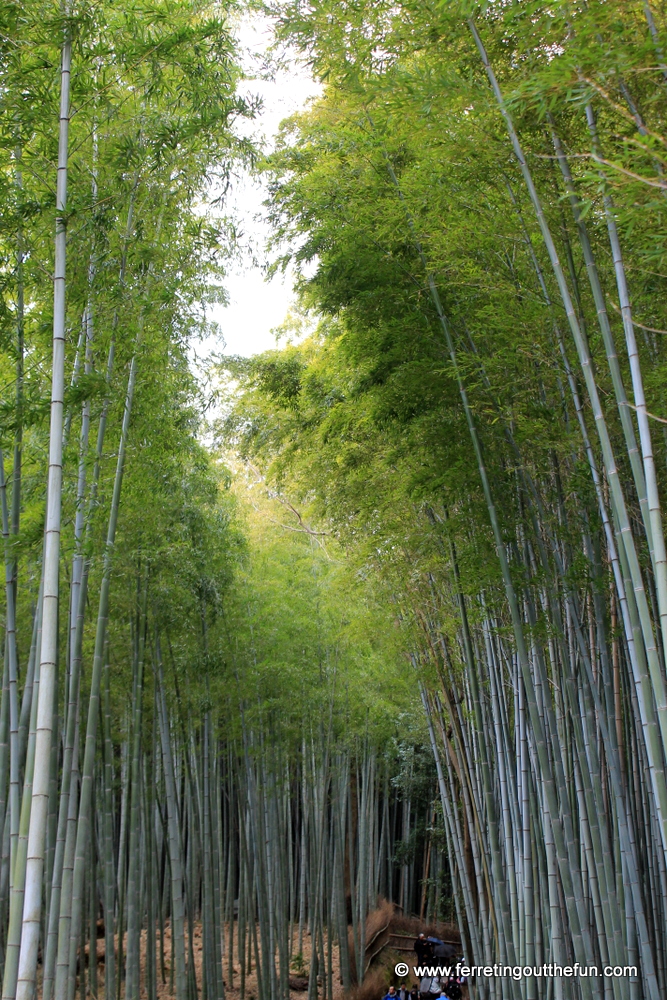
(205, 15, 320, 356)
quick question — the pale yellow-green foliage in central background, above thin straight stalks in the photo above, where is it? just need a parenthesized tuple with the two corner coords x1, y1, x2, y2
(204, 470, 417, 748)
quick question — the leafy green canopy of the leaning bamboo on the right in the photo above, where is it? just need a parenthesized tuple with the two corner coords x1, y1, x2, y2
(222, 3, 667, 664)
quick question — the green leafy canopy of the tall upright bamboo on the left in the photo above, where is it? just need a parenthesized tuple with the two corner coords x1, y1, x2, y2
(0, 0, 254, 744)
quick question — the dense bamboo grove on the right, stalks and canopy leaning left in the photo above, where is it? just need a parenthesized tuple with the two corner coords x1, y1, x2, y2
(215, 0, 667, 1000)
